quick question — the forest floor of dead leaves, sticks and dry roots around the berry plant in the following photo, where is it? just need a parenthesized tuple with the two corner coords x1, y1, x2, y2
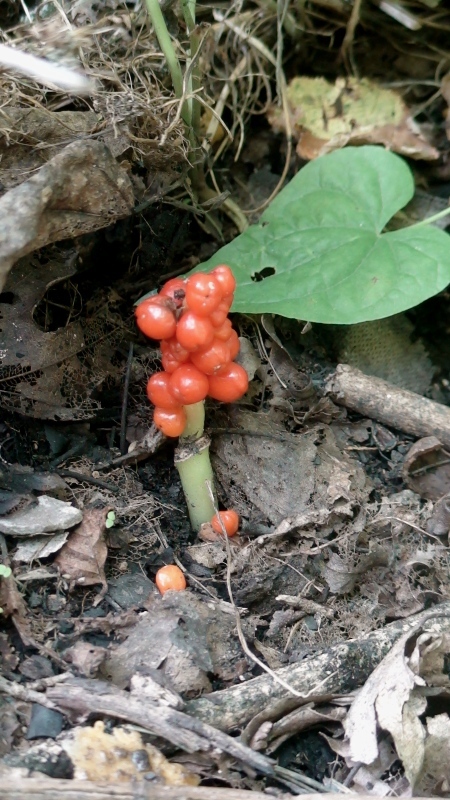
(0, 0, 450, 800)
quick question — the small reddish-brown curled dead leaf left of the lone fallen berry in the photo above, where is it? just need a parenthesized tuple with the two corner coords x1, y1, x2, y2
(54, 508, 111, 597)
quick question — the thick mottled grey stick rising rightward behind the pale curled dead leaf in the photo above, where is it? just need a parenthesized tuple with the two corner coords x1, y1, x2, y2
(185, 603, 450, 730)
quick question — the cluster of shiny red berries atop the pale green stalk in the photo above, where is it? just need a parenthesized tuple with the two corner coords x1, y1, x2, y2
(136, 264, 248, 436)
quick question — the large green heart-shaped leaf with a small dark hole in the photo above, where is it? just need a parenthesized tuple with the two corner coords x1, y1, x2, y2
(199, 146, 450, 324)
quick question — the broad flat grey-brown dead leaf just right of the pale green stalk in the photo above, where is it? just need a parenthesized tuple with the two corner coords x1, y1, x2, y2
(212, 409, 370, 525)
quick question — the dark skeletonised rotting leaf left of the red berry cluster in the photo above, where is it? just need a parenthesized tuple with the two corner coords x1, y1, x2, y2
(0, 253, 123, 422)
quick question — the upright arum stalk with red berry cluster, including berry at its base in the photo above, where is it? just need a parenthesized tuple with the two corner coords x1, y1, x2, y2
(136, 264, 248, 536)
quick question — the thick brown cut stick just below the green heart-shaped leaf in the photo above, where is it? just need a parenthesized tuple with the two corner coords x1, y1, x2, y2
(325, 364, 450, 447)
